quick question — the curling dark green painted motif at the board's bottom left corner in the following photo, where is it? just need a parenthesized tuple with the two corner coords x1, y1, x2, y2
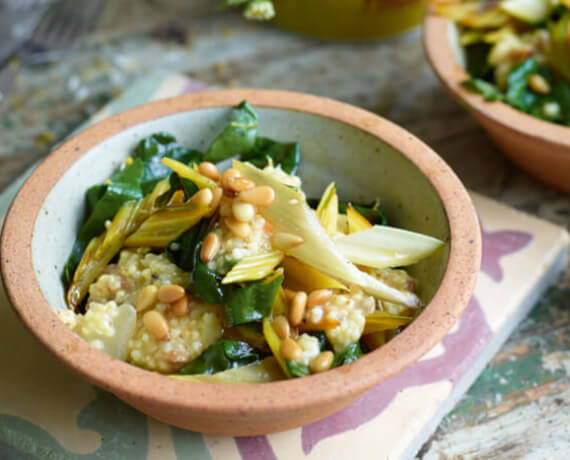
(0, 389, 148, 460)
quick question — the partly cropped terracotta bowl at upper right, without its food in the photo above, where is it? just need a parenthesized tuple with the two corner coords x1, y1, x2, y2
(424, 10, 570, 193)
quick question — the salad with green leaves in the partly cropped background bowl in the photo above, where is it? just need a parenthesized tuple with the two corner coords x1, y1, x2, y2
(435, 0, 570, 126)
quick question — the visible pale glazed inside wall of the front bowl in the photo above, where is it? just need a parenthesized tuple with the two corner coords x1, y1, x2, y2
(32, 108, 449, 316)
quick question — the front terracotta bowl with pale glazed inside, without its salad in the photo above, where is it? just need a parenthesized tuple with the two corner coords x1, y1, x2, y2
(1, 90, 481, 435)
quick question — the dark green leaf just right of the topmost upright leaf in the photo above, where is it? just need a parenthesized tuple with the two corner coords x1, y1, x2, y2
(240, 137, 301, 174)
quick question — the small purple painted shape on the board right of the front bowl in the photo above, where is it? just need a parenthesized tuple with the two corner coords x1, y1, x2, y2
(481, 225, 533, 283)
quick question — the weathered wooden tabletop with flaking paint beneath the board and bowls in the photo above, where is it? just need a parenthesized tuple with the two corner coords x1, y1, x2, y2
(0, 0, 570, 459)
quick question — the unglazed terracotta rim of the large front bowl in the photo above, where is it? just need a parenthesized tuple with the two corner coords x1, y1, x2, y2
(0, 89, 481, 434)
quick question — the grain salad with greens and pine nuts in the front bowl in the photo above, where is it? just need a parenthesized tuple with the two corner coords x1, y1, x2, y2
(58, 101, 443, 383)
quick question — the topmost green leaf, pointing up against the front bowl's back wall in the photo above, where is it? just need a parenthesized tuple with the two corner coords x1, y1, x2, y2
(203, 101, 258, 163)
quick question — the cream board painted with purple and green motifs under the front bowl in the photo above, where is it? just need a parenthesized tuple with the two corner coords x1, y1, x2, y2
(0, 74, 568, 460)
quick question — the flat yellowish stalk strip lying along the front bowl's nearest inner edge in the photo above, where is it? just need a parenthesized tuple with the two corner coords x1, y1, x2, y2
(170, 356, 285, 384)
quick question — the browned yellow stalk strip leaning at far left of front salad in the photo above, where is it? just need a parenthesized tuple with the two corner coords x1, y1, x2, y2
(67, 201, 142, 310)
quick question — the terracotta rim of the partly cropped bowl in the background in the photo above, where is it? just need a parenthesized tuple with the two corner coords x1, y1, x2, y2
(423, 7, 570, 150)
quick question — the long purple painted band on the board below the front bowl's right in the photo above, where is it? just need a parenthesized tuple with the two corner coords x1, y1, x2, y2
(300, 298, 492, 452)
